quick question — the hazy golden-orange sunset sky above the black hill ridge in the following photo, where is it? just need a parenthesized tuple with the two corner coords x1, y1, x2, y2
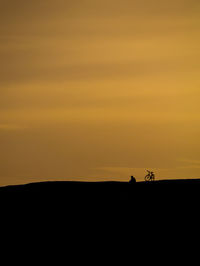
(0, 0, 200, 185)
